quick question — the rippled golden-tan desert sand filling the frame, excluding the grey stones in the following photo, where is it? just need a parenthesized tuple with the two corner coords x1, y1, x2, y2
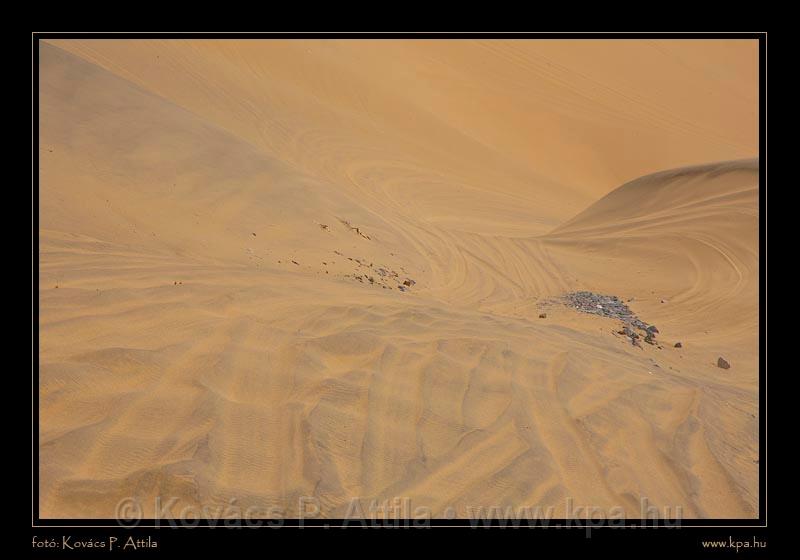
(39, 41, 759, 518)
